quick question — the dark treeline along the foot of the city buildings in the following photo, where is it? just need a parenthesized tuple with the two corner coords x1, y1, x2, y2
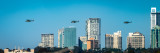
(0, 46, 160, 53)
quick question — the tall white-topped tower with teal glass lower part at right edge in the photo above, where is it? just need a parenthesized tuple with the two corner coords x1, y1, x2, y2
(151, 7, 160, 48)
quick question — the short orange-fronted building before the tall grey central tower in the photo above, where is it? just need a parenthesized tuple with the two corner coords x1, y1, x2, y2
(87, 38, 99, 50)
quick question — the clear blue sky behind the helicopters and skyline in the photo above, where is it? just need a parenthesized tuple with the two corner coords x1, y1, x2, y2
(0, 0, 160, 49)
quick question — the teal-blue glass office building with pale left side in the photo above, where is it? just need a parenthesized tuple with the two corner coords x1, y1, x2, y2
(58, 27, 76, 49)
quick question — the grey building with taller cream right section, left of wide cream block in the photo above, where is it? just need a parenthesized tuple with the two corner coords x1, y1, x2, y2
(105, 31, 122, 49)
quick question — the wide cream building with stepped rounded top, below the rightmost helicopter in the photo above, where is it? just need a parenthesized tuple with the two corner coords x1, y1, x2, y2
(127, 32, 145, 49)
